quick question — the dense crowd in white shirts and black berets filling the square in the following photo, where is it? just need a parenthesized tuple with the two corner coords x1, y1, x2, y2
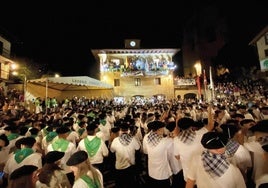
(0, 78, 268, 188)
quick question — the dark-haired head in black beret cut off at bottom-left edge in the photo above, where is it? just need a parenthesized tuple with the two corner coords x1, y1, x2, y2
(8, 165, 38, 188)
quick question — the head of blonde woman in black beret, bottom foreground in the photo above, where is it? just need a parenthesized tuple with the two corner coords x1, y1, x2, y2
(66, 150, 91, 179)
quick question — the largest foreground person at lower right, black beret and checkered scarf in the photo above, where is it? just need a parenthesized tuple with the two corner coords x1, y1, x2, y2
(185, 131, 246, 188)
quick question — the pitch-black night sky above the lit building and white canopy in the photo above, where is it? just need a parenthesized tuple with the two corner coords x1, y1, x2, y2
(0, 0, 268, 77)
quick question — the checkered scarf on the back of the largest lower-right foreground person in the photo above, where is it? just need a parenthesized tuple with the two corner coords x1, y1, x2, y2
(201, 150, 230, 178)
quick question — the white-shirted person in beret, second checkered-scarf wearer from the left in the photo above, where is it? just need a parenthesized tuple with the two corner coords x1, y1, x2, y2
(143, 120, 174, 188)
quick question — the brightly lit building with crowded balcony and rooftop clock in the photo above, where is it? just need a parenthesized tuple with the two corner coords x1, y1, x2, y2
(92, 39, 180, 99)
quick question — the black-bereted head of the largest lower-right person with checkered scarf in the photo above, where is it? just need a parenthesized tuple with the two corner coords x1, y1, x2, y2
(201, 131, 228, 154)
